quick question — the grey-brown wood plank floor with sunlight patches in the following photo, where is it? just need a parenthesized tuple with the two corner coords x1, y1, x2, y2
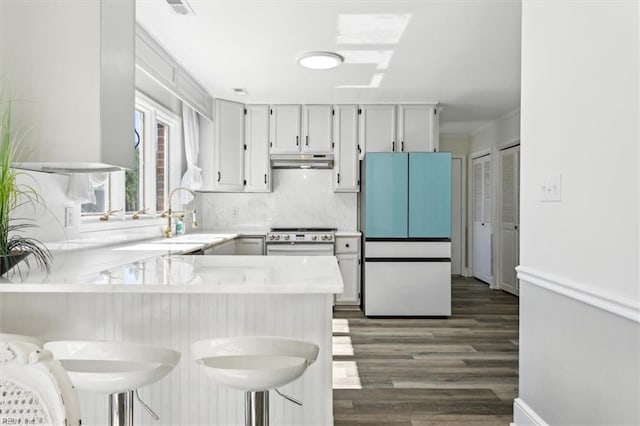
(333, 278, 518, 426)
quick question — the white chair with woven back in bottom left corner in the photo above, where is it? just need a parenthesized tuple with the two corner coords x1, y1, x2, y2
(0, 335, 81, 426)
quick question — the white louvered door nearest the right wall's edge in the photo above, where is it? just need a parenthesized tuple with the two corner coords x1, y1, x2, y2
(498, 146, 520, 294)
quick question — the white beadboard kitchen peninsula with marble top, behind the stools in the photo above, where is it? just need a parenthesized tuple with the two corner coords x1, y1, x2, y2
(0, 248, 343, 425)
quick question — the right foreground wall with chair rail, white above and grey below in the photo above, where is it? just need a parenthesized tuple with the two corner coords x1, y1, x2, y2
(515, 1, 640, 425)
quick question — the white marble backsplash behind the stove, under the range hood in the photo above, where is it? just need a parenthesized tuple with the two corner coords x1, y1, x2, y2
(196, 169, 357, 230)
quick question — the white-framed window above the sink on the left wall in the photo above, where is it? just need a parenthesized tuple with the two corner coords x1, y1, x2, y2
(82, 93, 182, 221)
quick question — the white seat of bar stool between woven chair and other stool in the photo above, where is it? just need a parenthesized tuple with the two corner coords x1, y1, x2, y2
(44, 340, 180, 393)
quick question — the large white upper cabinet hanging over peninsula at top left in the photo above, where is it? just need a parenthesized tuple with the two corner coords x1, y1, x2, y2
(0, 1, 135, 167)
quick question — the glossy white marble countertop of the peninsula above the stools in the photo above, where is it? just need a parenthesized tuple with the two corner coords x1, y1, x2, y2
(0, 255, 344, 294)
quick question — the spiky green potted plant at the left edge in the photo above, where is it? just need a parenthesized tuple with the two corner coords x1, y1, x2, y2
(0, 85, 53, 275)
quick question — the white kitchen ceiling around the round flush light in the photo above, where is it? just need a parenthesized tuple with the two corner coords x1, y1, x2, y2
(136, 0, 521, 133)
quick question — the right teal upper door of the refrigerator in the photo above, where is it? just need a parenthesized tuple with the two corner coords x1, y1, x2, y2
(409, 152, 451, 238)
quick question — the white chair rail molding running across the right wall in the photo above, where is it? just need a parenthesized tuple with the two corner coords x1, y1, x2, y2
(516, 266, 640, 323)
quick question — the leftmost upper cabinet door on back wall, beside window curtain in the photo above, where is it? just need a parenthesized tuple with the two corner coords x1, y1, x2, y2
(213, 99, 244, 192)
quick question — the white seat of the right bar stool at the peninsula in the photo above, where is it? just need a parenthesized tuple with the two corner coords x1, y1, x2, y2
(191, 336, 319, 392)
